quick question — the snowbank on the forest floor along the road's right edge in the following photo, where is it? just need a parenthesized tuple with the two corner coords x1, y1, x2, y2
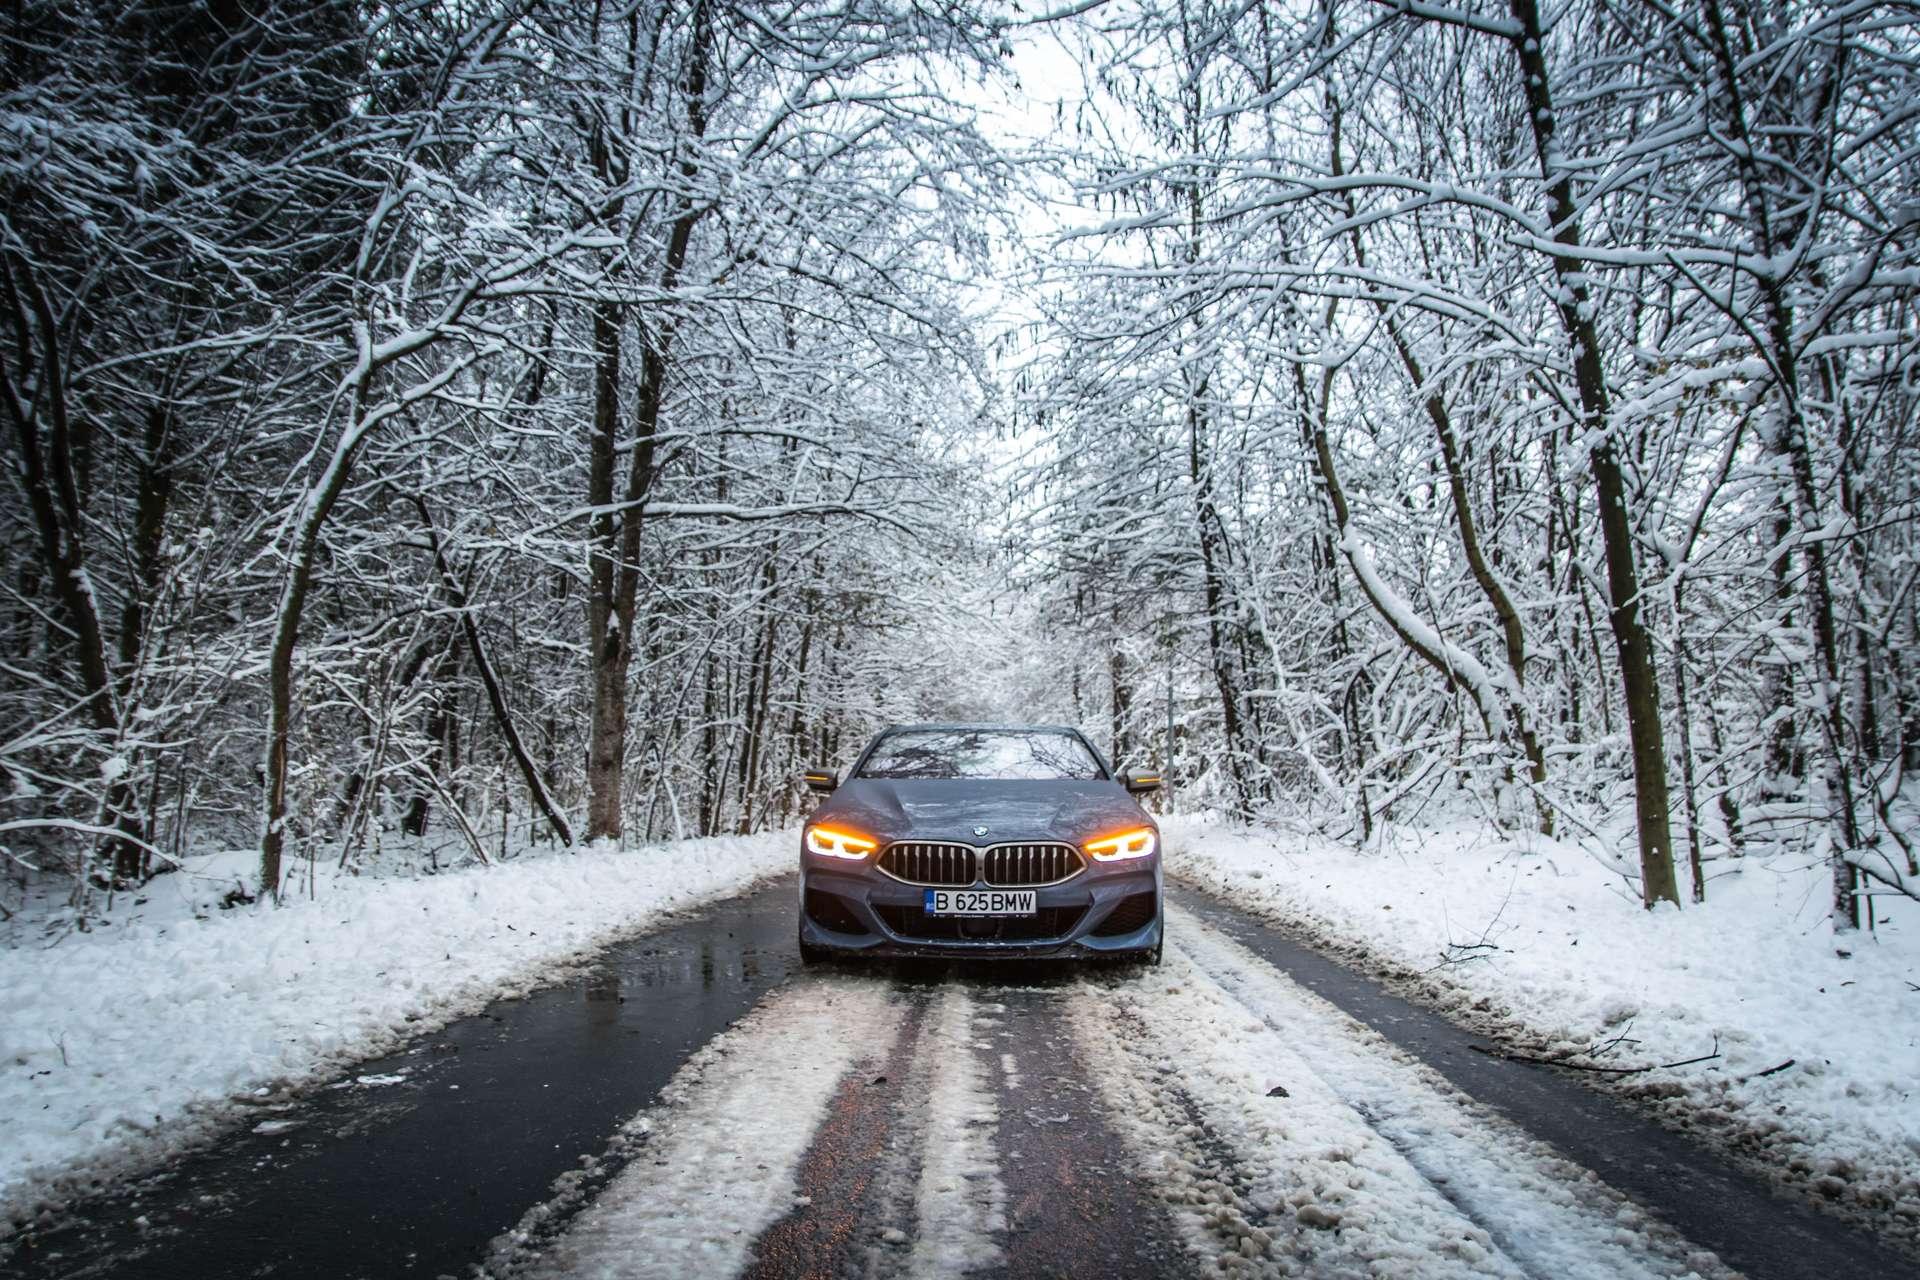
(1167, 821, 1920, 1234)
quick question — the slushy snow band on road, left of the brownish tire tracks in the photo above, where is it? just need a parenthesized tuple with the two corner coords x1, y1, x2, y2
(510, 975, 902, 1280)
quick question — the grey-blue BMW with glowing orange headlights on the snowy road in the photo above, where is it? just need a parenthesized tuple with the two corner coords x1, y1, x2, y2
(799, 723, 1165, 963)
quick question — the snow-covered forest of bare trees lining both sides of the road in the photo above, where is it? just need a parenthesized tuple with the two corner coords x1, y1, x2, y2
(0, 0, 1920, 931)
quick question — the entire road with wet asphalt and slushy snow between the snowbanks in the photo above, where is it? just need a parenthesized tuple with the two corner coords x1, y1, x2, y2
(0, 885, 1916, 1280)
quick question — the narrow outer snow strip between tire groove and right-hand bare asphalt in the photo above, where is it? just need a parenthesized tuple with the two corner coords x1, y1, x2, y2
(1169, 908, 1736, 1280)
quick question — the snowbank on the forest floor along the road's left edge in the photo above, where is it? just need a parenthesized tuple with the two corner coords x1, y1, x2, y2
(0, 833, 793, 1222)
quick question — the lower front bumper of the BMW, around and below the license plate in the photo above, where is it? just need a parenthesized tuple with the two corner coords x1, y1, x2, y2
(799, 854, 1162, 960)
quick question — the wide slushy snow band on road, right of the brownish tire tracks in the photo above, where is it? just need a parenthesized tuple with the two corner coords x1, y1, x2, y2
(1071, 915, 1713, 1280)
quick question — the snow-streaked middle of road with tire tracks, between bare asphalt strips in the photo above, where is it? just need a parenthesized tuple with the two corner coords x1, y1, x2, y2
(499, 912, 1728, 1280)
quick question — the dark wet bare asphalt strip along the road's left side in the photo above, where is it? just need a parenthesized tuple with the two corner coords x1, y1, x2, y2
(4, 881, 799, 1280)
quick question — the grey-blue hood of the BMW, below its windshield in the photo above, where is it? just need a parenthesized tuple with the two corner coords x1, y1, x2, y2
(814, 777, 1152, 844)
